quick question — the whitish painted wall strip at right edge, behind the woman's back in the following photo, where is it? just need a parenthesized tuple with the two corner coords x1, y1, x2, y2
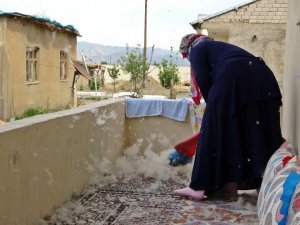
(282, 0, 300, 153)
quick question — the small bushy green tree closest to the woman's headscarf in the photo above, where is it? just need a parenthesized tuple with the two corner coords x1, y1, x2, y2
(158, 59, 179, 88)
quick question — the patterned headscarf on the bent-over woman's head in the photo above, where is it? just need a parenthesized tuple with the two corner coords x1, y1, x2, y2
(179, 34, 209, 58)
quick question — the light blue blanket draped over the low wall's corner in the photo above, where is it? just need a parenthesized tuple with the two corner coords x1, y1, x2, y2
(126, 98, 188, 121)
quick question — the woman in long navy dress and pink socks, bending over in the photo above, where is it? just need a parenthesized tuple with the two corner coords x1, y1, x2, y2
(175, 34, 283, 200)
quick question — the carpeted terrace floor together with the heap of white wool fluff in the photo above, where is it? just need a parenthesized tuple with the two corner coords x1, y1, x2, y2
(39, 149, 259, 225)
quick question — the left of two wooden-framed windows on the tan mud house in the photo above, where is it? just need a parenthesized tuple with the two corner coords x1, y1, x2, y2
(26, 47, 39, 82)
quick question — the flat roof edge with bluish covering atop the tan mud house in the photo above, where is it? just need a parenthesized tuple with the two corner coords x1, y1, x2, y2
(0, 11, 81, 37)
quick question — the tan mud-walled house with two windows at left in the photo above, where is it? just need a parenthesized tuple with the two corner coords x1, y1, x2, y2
(0, 11, 80, 120)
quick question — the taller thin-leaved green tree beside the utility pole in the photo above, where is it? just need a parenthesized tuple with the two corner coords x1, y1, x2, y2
(120, 45, 154, 97)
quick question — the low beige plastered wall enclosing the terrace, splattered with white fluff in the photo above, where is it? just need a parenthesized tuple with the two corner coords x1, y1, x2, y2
(0, 99, 192, 225)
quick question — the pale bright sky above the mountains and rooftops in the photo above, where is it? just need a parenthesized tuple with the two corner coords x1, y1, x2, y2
(0, 0, 247, 50)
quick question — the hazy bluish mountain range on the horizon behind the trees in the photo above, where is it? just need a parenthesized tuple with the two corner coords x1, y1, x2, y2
(77, 41, 189, 66)
